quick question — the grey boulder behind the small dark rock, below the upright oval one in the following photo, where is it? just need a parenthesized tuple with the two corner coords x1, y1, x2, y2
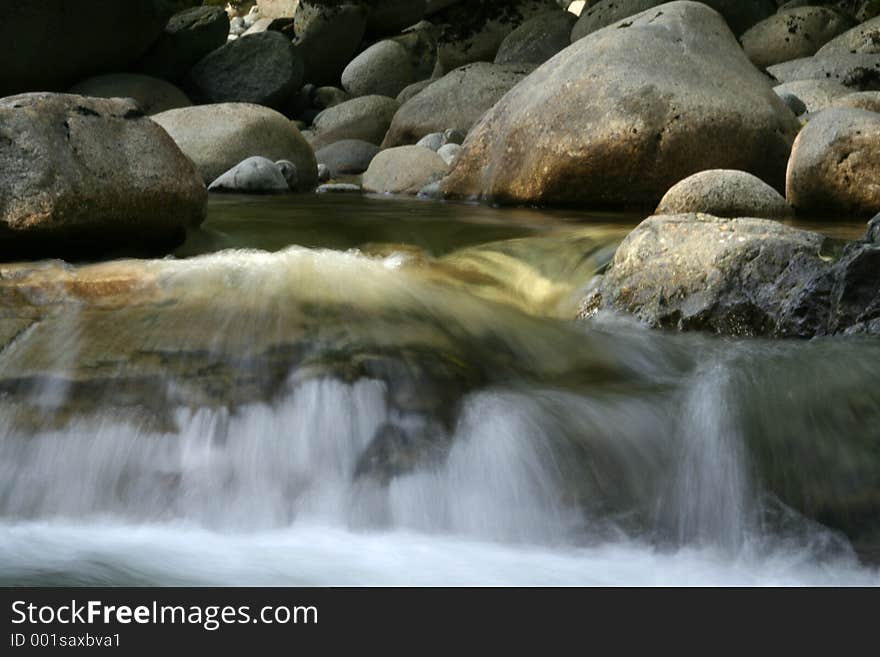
(312, 96, 398, 150)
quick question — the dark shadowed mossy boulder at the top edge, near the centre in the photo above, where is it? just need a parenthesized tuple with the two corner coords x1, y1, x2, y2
(431, 0, 558, 75)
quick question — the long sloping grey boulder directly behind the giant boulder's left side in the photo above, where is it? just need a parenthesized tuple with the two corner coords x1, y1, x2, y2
(383, 62, 531, 148)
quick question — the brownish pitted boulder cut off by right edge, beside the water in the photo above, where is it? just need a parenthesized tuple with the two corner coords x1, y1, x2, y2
(786, 108, 880, 216)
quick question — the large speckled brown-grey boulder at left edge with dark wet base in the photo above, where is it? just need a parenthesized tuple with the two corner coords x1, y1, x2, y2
(0, 93, 207, 258)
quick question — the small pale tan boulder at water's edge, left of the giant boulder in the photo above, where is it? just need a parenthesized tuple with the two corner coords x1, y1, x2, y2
(363, 146, 448, 194)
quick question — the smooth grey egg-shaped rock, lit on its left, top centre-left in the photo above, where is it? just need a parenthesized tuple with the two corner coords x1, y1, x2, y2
(342, 40, 415, 98)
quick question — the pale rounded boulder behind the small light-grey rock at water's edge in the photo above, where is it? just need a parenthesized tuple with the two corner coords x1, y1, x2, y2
(153, 103, 318, 189)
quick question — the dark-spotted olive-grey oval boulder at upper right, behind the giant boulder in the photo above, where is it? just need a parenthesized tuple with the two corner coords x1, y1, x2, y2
(740, 7, 853, 68)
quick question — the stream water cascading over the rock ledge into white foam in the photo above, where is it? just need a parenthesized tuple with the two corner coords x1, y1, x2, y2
(0, 197, 880, 585)
